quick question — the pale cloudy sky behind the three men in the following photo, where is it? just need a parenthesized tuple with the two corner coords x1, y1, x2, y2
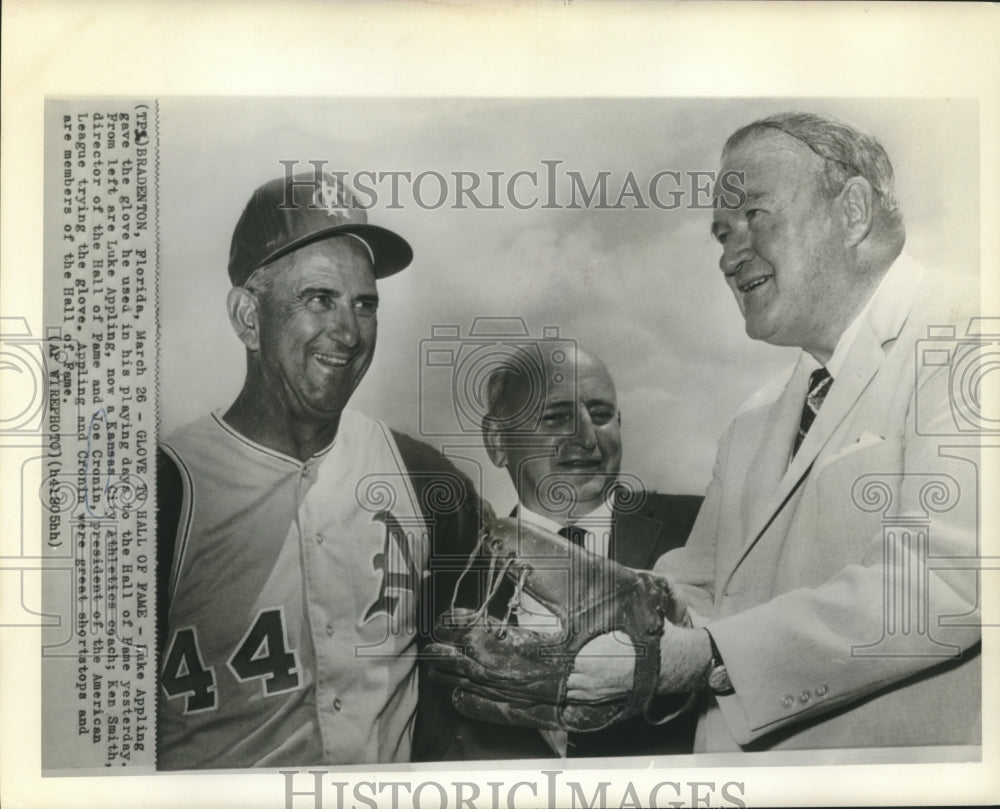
(159, 98, 980, 509)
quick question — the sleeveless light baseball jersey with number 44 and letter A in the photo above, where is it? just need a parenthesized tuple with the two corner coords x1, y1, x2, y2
(158, 410, 429, 769)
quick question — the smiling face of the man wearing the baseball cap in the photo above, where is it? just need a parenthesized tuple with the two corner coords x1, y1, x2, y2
(250, 238, 378, 422)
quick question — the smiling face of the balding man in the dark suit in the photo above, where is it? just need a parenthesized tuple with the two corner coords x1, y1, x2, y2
(486, 350, 622, 521)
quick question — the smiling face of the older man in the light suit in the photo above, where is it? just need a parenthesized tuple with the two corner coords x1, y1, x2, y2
(712, 129, 870, 362)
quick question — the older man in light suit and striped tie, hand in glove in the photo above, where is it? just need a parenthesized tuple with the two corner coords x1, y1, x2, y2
(570, 113, 981, 752)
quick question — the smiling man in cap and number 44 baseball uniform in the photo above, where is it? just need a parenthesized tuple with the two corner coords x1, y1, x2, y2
(157, 173, 479, 769)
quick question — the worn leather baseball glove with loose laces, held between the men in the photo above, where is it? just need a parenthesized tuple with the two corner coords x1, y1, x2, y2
(426, 518, 687, 732)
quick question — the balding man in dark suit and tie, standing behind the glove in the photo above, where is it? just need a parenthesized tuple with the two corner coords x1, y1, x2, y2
(426, 341, 702, 759)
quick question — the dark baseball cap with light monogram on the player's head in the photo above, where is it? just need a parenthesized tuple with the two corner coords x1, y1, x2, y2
(229, 172, 413, 286)
